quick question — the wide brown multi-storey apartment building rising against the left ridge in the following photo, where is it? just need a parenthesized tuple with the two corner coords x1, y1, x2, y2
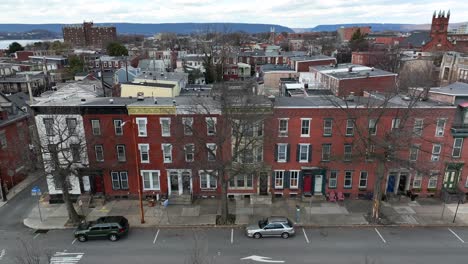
(62, 22, 117, 47)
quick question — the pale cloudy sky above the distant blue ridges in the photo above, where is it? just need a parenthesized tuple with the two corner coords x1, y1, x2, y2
(0, 0, 468, 28)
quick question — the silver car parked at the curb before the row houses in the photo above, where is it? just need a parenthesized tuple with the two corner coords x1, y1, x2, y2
(245, 216, 295, 239)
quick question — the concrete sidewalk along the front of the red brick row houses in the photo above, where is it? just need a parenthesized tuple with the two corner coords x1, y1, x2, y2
(24, 195, 468, 229)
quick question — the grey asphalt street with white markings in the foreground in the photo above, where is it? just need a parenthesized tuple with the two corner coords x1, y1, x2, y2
(0, 227, 468, 264)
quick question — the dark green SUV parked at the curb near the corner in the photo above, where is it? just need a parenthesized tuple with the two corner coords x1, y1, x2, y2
(75, 216, 130, 242)
